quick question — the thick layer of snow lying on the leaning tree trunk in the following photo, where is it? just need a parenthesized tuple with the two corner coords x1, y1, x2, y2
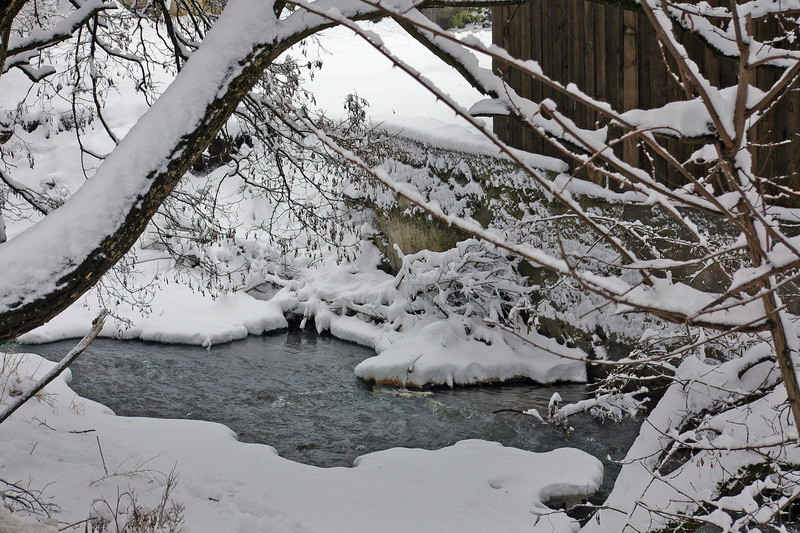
(0, 1, 284, 314)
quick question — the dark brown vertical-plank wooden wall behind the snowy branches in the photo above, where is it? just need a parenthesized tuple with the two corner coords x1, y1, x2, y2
(492, 0, 800, 205)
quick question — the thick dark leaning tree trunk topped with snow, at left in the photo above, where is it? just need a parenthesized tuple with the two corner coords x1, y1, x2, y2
(0, 0, 290, 343)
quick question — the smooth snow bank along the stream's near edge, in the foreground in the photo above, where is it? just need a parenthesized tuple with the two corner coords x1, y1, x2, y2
(0, 355, 603, 533)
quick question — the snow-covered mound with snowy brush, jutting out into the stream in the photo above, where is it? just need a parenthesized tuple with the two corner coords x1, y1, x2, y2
(300, 250, 586, 387)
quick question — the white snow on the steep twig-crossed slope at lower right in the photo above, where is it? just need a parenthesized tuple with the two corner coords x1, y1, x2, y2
(582, 343, 800, 533)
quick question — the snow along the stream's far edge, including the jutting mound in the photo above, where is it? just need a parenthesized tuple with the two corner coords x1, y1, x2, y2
(19, 243, 586, 387)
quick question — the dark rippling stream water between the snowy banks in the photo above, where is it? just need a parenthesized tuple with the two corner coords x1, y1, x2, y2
(17, 329, 639, 500)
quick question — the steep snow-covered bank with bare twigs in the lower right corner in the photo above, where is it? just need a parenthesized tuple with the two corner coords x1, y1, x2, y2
(582, 343, 800, 533)
